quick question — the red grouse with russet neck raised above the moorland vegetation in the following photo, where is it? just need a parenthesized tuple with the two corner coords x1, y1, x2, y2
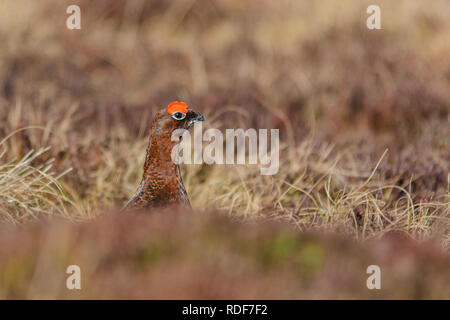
(124, 101, 205, 209)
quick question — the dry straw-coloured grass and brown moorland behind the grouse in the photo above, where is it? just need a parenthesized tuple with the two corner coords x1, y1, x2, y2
(0, 0, 450, 298)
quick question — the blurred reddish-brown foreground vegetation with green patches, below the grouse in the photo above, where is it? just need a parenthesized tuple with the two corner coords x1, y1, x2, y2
(0, 211, 450, 299)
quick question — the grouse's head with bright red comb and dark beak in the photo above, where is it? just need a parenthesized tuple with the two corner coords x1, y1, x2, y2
(151, 101, 205, 137)
